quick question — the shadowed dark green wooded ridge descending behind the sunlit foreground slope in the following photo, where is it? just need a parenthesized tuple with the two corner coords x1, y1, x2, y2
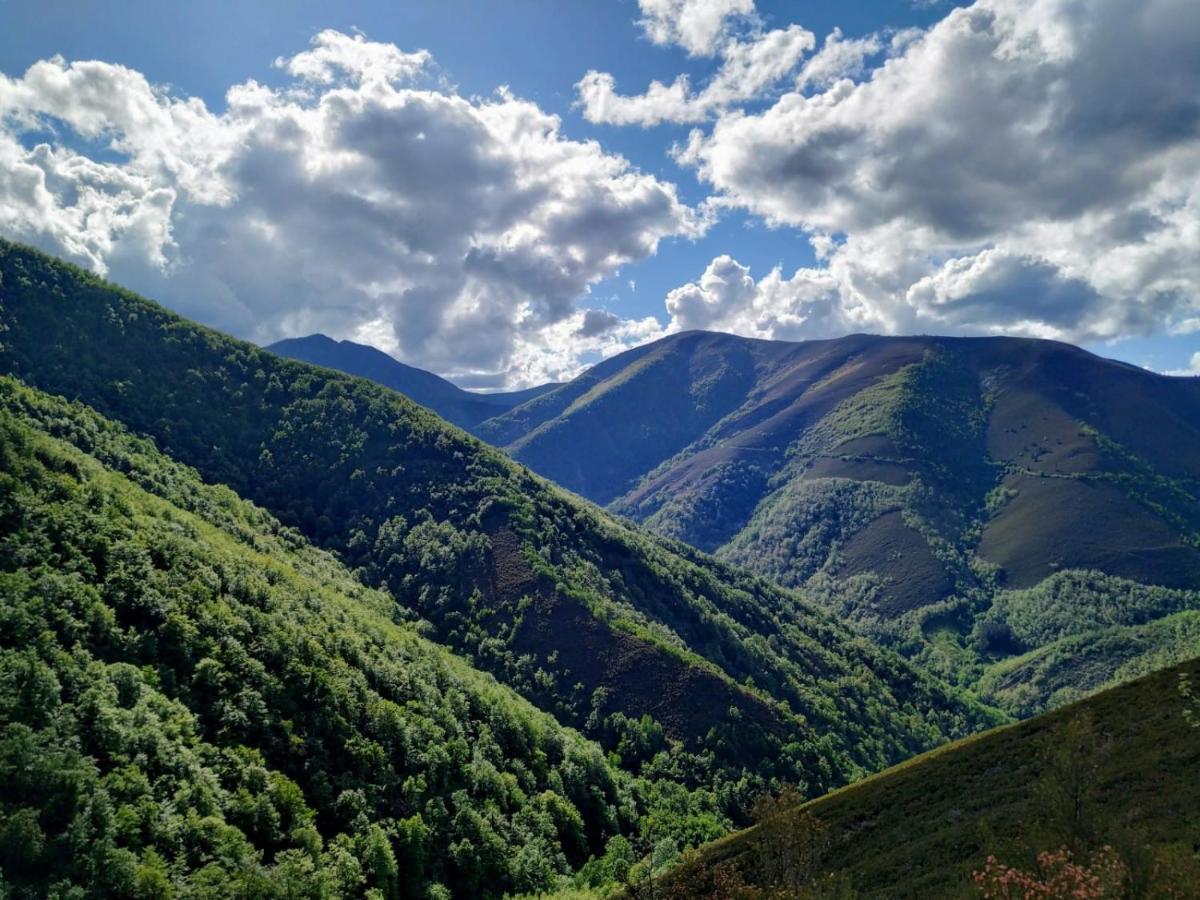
(0, 244, 996, 818)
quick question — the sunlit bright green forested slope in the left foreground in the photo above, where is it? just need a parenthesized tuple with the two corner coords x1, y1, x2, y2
(0, 378, 686, 898)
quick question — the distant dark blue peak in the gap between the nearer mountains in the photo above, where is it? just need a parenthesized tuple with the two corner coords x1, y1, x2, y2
(266, 335, 558, 428)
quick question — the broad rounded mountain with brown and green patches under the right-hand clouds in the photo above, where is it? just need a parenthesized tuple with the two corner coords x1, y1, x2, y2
(476, 332, 1200, 714)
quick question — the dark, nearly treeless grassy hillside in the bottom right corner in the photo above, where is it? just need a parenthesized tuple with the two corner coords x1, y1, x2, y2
(657, 660, 1200, 900)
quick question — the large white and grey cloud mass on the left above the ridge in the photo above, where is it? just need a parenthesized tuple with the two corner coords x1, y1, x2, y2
(0, 31, 706, 385)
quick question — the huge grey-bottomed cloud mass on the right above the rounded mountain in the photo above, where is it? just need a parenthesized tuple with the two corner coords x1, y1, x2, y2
(672, 0, 1200, 341)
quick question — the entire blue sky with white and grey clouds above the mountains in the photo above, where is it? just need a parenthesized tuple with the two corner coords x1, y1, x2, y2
(0, 0, 1200, 390)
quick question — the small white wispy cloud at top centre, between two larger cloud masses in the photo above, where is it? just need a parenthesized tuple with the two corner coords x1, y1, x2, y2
(575, 0, 816, 127)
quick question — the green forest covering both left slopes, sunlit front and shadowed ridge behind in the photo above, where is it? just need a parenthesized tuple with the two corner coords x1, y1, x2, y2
(0, 245, 988, 896)
